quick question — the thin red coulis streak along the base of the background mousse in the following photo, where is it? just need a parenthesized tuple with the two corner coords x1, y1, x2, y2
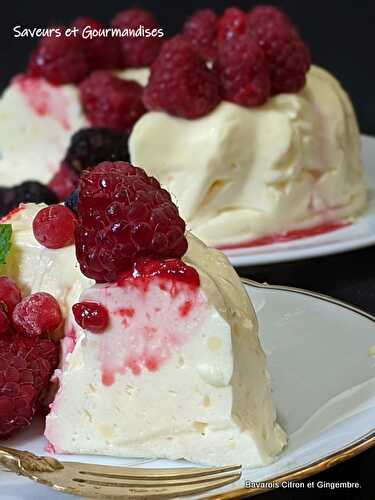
(217, 222, 351, 250)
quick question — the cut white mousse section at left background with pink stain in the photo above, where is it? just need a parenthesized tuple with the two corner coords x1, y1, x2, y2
(0, 68, 148, 187)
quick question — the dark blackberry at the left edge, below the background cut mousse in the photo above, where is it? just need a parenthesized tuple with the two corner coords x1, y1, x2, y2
(0, 181, 59, 216)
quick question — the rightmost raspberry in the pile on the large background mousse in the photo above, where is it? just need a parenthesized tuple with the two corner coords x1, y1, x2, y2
(248, 5, 310, 95)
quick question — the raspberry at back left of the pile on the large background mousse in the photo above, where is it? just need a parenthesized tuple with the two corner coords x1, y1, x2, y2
(183, 9, 217, 61)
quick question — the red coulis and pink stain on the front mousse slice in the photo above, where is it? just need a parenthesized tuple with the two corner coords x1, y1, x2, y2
(99, 260, 201, 386)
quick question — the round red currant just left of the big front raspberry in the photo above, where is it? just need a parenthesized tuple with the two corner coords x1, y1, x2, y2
(33, 205, 76, 248)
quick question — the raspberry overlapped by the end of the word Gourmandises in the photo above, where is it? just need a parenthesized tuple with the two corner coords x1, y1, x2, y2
(111, 9, 162, 68)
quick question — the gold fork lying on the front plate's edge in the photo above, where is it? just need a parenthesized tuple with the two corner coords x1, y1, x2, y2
(0, 446, 241, 499)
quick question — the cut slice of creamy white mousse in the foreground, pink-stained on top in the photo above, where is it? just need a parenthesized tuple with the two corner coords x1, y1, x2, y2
(45, 235, 286, 467)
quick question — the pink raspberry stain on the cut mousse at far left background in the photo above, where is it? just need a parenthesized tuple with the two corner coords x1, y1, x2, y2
(12, 75, 70, 130)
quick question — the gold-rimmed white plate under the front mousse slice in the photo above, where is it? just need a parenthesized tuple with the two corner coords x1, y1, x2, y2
(0, 280, 375, 500)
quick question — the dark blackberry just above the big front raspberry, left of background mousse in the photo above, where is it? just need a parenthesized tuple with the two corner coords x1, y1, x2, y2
(64, 127, 129, 174)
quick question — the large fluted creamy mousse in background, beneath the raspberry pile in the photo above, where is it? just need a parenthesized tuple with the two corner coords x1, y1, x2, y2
(129, 66, 366, 246)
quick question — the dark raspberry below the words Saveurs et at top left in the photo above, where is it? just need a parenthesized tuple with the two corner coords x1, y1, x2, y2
(28, 27, 91, 85)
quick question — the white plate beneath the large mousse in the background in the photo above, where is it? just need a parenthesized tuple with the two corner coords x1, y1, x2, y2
(224, 135, 375, 266)
